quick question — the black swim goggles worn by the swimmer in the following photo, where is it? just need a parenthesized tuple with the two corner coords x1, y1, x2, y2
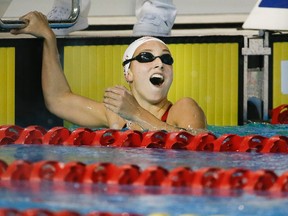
(122, 52, 174, 66)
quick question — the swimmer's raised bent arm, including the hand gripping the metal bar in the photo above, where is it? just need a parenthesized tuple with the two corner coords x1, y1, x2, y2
(11, 12, 107, 127)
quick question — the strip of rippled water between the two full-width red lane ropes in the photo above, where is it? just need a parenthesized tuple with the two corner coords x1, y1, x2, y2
(0, 145, 288, 175)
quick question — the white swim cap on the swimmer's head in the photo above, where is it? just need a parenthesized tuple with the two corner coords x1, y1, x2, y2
(123, 36, 166, 77)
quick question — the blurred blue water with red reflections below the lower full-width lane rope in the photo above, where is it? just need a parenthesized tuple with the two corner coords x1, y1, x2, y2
(0, 182, 288, 216)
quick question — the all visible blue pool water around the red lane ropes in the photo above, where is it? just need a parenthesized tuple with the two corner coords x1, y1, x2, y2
(0, 124, 288, 216)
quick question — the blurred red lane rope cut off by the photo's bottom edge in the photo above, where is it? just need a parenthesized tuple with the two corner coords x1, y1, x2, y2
(0, 208, 141, 216)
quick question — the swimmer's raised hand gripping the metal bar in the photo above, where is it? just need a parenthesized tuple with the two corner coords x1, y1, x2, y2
(11, 11, 53, 38)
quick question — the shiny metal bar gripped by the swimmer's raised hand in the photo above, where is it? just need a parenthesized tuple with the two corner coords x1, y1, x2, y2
(0, 0, 80, 29)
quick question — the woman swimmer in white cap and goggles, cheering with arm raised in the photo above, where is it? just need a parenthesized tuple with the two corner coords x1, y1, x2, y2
(11, 12, 207, 135)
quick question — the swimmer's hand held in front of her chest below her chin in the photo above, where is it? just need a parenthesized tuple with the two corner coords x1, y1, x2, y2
(103, 86, 140, 121)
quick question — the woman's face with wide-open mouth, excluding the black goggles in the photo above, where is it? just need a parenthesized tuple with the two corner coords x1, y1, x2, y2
(126, 41, 173, 104)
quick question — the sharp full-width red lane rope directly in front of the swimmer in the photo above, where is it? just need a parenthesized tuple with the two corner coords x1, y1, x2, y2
(0, 125, 288, 153)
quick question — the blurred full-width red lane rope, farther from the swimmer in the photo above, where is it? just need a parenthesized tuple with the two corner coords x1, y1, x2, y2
(0, 160, 288, 194)
